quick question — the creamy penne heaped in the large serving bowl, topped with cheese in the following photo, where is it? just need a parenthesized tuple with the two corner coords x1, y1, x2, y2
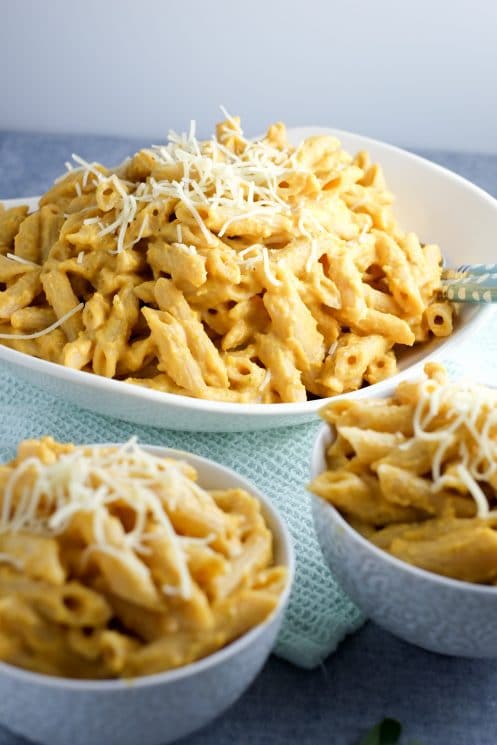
(0, 117, 454, 404)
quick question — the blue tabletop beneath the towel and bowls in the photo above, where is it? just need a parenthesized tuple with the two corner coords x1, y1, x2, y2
(0, 131, 497, 745)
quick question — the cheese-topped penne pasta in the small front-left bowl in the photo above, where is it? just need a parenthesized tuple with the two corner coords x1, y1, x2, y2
(0, 438, 287, 679)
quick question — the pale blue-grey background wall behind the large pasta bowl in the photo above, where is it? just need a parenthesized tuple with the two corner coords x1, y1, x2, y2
(0, 0, 497, 152)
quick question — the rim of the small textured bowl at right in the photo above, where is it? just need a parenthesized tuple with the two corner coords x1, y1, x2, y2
(308, 422, 497, 595)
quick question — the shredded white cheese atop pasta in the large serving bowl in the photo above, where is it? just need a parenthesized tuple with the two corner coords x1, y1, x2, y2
(61, 107, 345, 264)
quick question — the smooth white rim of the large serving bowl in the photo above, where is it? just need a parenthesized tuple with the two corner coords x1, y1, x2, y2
(0, 125, 497, 416)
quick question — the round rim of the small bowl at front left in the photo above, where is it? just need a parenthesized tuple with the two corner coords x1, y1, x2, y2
(0, 443, 295, 693)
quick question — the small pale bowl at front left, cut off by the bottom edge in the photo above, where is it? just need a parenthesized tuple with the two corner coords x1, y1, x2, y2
(0, 446, 294, 745)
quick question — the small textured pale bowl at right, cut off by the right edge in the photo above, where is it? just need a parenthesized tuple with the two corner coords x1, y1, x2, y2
(311, 424, 497, 657)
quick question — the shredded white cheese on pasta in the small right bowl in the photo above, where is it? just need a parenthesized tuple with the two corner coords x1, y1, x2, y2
(413, 380, 497, 518)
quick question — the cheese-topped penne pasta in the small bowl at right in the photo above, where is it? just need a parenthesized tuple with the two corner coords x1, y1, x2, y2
(309, 364, 497, 584)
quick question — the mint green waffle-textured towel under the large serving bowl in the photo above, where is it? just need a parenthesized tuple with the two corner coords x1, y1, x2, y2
(0, 316, 497, 668)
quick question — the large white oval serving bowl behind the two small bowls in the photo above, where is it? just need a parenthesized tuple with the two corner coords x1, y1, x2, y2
(0, 127, 497, 432)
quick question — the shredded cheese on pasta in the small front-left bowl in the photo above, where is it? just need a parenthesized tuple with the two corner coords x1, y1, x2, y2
(0, 438, 211, 599)
